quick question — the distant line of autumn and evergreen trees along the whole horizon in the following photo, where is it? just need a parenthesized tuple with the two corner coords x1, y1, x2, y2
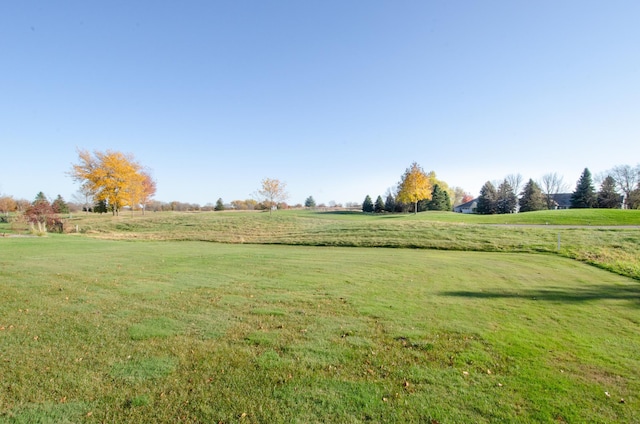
(0, 154, 640, 231)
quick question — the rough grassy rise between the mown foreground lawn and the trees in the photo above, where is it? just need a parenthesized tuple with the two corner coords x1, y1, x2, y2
(63, 210, 640, 279)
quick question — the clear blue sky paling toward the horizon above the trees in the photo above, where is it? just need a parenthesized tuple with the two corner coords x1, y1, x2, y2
(0, 0, 640, 205)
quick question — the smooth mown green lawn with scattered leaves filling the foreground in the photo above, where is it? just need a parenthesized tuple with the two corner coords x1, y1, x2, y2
(0, 237, 640, 423)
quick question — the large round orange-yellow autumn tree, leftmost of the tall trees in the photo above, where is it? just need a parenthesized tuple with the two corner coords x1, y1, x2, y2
(71, 150, 150, 215)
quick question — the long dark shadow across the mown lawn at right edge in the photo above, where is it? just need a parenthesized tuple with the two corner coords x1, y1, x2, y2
(440, 284, 640, 307)
